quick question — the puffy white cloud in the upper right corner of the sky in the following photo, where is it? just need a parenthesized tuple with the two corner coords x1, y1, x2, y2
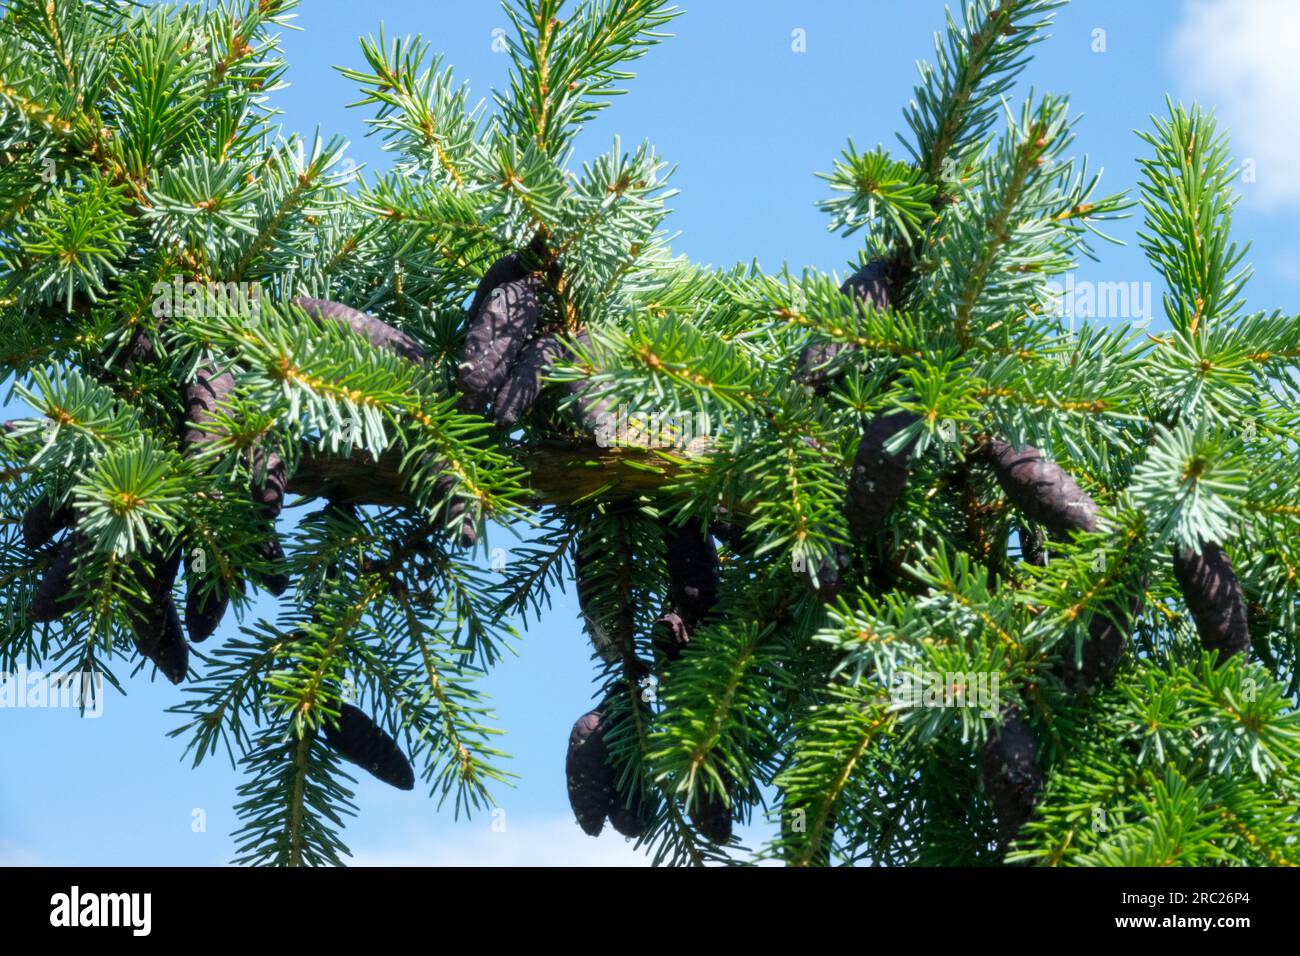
(1169, 0, 1300, 208)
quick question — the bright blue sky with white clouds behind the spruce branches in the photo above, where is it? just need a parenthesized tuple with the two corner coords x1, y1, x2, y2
(0, 0, 1300, 865)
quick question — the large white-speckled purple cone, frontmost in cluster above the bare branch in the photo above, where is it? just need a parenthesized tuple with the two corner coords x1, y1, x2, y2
(458, 276, 542, 414)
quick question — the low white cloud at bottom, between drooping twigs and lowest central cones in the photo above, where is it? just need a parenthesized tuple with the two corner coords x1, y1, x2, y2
(343, 817, 650, 866)
